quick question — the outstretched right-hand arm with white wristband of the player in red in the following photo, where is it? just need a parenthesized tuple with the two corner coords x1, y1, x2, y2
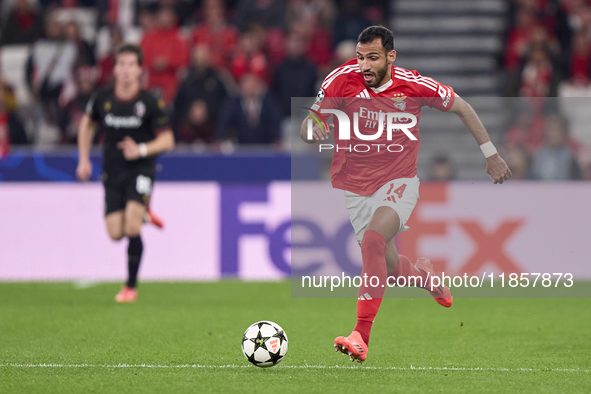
(449, 93, 512, 183)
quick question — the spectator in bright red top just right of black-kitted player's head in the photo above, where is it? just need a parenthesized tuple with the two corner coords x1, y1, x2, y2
(141, 7, 188, 104)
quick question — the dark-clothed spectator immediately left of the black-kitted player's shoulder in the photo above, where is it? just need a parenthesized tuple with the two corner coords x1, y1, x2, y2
(60, 66, 98, 144)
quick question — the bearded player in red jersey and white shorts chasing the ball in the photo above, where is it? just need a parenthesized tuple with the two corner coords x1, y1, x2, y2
(300, 26, 511, 363)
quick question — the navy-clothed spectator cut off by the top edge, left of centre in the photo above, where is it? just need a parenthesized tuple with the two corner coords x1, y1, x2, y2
(235, 0, 287, 32)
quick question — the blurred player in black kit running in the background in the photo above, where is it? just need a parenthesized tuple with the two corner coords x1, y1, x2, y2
(76, 44, 174, 302)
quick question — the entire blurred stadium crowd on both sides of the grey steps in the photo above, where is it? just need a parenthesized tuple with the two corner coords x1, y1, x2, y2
(0, 0, 591, 180)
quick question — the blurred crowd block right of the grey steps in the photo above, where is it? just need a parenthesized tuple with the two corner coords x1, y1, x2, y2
(502, 0, 591, 180)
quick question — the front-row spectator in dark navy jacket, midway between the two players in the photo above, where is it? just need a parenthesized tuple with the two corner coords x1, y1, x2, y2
(217, 74, 281, 145)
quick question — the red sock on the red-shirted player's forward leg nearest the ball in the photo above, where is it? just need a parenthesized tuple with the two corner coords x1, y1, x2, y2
(354, 230, 388, 344)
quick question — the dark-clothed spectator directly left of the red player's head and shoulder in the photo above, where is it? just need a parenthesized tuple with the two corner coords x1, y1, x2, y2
(272, 34, 318, 117)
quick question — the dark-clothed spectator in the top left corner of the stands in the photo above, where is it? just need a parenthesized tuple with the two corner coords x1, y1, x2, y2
(0, 0, 43, 45)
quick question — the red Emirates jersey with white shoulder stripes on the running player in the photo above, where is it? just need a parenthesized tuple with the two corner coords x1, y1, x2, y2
(312, 59, 455, 196)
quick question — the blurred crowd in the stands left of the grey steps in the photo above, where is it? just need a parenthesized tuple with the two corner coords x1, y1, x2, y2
(0, 0, 389, 149)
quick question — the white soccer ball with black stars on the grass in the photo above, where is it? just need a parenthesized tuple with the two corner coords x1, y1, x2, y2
(242, 320, 287, 368)
